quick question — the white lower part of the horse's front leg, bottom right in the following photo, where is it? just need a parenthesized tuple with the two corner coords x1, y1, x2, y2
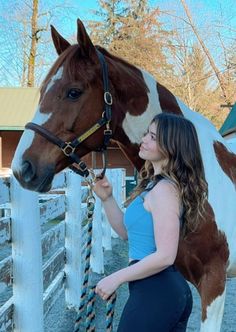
(200, 288, 226, 332)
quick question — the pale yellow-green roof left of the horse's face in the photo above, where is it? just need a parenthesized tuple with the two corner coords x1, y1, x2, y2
(0, 88, 40, 130)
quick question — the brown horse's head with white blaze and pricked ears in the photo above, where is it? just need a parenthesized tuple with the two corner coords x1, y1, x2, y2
(12, 20, 113, 192)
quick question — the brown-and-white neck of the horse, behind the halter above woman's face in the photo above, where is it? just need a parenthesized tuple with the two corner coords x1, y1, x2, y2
(111, 62, 181, 145)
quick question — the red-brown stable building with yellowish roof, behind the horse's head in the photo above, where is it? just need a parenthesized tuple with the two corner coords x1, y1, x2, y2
(0, 88, 135, 176)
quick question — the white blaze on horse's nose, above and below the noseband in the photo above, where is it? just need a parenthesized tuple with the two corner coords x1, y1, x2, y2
(11, 107, 51, 173)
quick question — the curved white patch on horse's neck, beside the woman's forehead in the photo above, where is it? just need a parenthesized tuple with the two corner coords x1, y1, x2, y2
(122, 70, 162, 144)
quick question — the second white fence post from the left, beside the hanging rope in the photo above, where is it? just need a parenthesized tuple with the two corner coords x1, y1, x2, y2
(65, 171, 82, 308)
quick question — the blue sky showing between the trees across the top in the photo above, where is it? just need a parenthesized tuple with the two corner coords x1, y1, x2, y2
(0, 0, 236, 84)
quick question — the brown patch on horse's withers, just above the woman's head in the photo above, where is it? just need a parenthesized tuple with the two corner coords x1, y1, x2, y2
(157, 82, 183, 115)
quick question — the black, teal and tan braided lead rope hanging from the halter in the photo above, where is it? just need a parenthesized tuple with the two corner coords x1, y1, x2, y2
(74, 175, 116, 332)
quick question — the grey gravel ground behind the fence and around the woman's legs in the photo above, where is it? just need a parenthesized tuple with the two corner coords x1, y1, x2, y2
(45, 239, 236, 332)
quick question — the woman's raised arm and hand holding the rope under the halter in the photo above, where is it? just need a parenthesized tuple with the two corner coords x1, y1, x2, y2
(93, 177, 128, 240)
